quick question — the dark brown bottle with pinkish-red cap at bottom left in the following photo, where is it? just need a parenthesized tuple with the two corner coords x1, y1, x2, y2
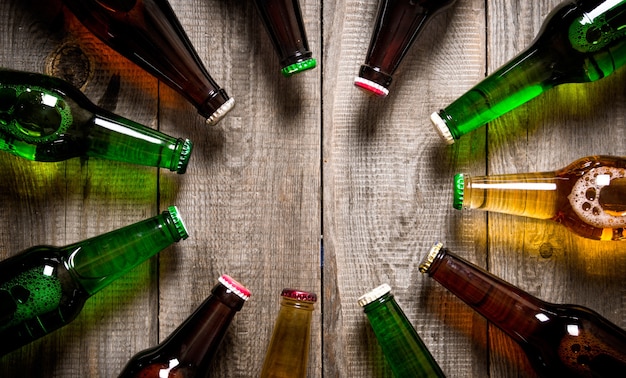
(119, 275, 250, 378)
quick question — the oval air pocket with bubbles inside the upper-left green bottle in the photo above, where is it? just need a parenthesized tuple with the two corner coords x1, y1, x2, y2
(0, 85, 72, 144)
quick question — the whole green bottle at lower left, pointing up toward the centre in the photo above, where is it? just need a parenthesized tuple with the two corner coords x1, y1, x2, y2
(0, 206, 188, 356)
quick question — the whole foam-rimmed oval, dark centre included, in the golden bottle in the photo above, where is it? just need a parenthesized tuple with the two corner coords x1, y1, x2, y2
(567, 167, 626, 228)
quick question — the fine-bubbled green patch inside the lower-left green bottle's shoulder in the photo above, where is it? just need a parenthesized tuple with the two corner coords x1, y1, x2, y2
(0, 265, 62, 331)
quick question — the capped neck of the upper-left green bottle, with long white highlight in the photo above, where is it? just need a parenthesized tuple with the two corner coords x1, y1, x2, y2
(86, 113, 192, 173)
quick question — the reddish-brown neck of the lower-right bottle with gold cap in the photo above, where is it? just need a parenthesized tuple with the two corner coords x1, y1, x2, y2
(420, 244, 553, 345)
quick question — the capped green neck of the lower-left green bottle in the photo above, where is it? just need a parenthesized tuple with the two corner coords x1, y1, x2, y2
(62, 212, 186, 295)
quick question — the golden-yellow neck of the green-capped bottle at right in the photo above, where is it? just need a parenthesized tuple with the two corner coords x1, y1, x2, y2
(455, 172, 569, 219)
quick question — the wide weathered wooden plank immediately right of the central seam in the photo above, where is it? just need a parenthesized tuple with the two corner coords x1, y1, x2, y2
(323, 0, 488, 377)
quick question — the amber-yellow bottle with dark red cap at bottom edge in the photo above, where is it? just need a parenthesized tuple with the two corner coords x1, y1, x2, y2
(261, 289, 317, 378)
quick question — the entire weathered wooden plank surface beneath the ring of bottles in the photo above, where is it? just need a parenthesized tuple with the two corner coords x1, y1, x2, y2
(0, 0, 626, 377)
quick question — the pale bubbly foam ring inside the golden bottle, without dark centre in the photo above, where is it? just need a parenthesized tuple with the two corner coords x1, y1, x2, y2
(567, 167, 626, 228)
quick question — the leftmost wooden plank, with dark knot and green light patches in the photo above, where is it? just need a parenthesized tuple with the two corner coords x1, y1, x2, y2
(0, 0, 158, 377)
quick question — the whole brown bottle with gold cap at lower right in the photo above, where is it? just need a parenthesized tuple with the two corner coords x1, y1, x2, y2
(419, 243, 626, 377)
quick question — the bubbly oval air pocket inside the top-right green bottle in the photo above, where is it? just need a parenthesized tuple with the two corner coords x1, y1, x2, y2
(569, 0, 626, 53)
